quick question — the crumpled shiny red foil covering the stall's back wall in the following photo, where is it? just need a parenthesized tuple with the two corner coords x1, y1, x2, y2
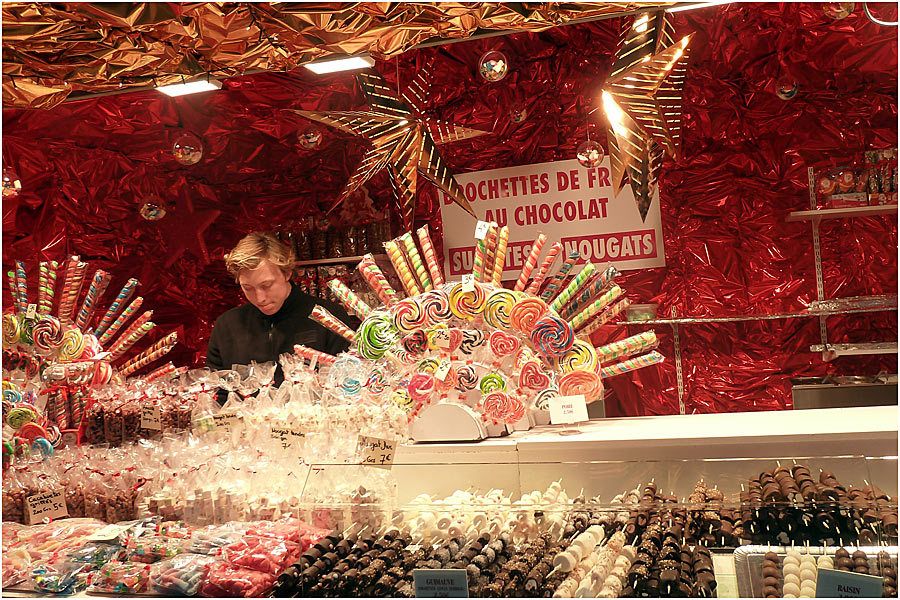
(3, 4, 897, 415)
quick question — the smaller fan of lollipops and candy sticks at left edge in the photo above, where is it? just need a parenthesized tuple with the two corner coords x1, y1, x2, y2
(3, 256, 178, 386)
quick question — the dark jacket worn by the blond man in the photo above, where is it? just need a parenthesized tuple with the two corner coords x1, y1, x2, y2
(206, 284, 356, 385)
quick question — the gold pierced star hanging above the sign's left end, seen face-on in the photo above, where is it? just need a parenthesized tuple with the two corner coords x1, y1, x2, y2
(294, 65, 487, 228)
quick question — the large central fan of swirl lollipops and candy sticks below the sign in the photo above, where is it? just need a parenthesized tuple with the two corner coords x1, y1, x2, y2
(298, 222, 663, 438)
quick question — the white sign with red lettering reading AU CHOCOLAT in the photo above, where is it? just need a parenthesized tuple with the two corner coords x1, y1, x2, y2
(440, 157, 666, 280)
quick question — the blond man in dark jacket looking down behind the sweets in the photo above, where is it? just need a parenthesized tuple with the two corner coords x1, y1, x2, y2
(206, 233, 348, 385)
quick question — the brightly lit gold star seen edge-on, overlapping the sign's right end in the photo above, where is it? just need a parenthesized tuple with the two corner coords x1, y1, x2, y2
(602, 12, 693, 220)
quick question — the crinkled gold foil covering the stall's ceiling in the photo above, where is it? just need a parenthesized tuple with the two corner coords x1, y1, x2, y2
(2, 2, 672, 108)
